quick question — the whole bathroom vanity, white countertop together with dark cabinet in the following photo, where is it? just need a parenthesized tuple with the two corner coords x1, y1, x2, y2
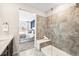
(0, 36, 13, 56)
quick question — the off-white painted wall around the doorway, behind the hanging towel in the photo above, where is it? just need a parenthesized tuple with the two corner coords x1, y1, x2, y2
(0, 4, 45, 53)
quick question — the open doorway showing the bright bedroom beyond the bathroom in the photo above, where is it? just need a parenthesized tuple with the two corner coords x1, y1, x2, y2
(19, 10, 36, 51)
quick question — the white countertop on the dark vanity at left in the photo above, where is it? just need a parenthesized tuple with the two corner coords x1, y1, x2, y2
(0, 35, 13, 55)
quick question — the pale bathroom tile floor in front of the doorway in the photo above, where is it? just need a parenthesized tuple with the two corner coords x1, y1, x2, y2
(18, 48, 45, 56)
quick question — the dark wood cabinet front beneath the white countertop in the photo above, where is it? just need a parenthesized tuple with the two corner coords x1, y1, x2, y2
(1, 39, 13, 56)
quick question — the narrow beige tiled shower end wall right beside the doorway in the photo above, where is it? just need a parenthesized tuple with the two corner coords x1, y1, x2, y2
(36, 15, 47, 39)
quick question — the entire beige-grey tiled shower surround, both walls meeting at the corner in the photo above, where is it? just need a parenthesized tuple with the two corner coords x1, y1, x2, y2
(36, 6, 79, 56)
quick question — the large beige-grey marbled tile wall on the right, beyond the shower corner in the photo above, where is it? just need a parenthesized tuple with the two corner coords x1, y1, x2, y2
(50, 6, 79, 56)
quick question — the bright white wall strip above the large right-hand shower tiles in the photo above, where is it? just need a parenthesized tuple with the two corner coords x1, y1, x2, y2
(46, 3, 75, 16)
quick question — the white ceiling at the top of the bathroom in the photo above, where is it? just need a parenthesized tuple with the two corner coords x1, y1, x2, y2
(26, 3, 64, 12)
